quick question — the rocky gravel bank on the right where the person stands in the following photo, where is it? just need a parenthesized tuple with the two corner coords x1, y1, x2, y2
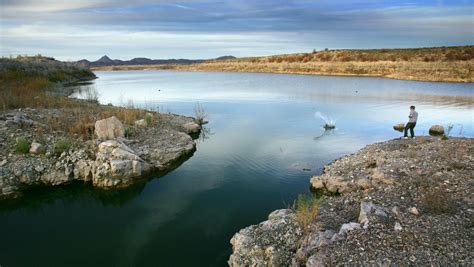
(228, 137, 474, 266)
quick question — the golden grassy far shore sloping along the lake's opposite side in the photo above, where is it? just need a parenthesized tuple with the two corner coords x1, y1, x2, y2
(92, 46, 474, 82)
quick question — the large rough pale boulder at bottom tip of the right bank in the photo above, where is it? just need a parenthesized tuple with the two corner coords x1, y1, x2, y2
(228, 210, 302, 266)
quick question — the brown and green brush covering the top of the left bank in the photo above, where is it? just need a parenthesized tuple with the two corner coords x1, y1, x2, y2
(0, 56, 167, 142)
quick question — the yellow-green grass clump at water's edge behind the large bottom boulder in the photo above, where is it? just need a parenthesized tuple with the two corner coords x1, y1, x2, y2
(292, 194, 323, 233)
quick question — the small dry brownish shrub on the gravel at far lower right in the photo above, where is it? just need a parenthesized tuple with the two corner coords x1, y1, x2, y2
(421, 187, 456, 214)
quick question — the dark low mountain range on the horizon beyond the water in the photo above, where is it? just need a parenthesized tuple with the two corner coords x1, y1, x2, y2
(76, 56, 235, 67)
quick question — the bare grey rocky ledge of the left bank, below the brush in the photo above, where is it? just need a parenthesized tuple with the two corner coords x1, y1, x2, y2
(0, 107, 200, 198)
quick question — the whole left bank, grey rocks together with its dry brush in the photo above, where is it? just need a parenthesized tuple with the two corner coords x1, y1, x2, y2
(0, 65, 201, 199)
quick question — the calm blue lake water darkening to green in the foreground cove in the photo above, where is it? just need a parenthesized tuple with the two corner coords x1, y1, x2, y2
(0, 71, 474, 266)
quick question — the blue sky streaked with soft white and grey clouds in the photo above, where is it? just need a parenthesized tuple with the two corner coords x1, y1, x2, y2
(0, 0, 474, 60)
